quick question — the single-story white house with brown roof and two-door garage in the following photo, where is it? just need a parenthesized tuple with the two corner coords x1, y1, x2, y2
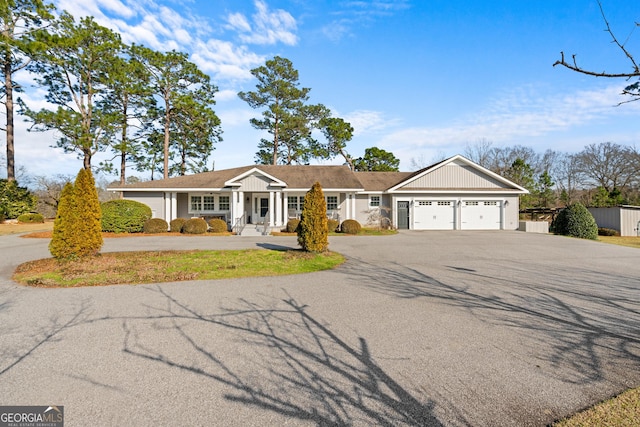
(109, 155, 527, 234)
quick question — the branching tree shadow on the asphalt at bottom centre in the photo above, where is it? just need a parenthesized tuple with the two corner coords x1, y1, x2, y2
(123, 288, 442, 426)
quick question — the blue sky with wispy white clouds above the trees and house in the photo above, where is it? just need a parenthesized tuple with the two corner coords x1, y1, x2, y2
(7, 0, 640, 179)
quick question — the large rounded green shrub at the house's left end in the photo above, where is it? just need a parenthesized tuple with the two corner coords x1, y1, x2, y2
(100, 199, 151, 233)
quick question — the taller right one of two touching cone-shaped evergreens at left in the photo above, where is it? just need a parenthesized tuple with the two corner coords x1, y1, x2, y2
(74, 169, 102, 257)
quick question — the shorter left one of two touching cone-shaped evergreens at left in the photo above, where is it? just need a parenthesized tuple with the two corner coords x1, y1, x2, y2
(49, 182, 79, 260)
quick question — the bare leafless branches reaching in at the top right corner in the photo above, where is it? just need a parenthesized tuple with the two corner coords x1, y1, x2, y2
(553, 0, 640, 105)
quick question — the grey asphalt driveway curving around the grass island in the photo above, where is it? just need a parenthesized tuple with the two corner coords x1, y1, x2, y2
(0, 231, 640, 426)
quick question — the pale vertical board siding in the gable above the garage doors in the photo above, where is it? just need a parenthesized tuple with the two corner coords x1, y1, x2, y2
(402, 163, 505, 190)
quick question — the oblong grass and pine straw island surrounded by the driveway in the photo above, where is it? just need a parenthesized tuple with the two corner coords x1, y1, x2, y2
(13, 249, 344, 287)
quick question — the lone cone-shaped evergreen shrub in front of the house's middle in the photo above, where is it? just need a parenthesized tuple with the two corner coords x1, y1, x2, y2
(296, 182, 329, 252)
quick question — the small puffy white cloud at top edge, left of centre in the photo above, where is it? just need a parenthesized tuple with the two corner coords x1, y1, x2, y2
(227, 0, 298, 46)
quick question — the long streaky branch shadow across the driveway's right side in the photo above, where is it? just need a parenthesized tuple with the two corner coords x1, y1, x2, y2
(341, 260, 640, 384)
